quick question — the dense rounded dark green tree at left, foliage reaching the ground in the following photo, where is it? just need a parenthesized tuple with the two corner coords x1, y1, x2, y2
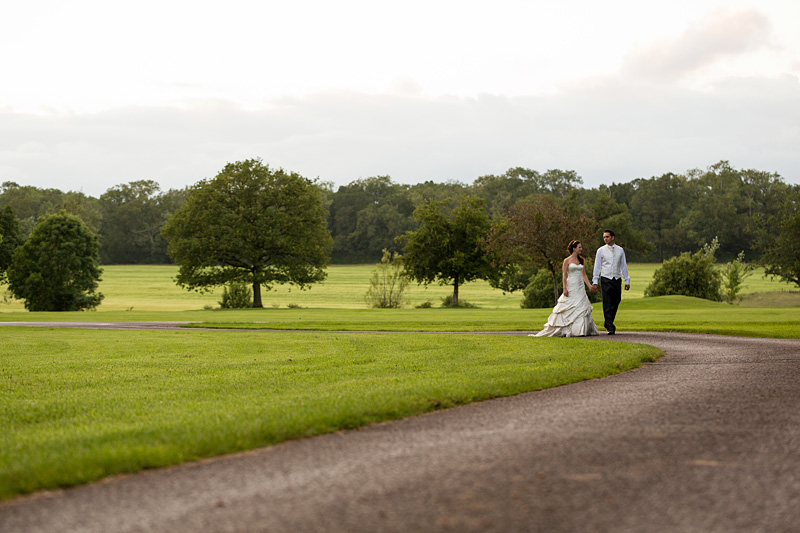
(8, 211, 103, 311)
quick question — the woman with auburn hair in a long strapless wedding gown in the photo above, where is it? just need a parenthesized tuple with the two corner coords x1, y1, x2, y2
(529, 241, 600, 337)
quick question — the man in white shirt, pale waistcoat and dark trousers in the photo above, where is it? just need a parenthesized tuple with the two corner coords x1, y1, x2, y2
(592, 229, 631, 335)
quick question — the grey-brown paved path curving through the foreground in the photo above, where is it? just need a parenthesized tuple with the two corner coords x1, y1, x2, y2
(0, 333, 800, 533)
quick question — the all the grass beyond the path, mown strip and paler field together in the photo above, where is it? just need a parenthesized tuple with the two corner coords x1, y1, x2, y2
(0, 264, 800, 338)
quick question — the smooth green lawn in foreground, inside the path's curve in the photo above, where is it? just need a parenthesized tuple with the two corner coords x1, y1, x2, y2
(0, 327, 660, 498)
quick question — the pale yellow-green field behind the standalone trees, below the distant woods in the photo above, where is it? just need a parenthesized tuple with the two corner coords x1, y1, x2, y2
(0, 264, 800, 312)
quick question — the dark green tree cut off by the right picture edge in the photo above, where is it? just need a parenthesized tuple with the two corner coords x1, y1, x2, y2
(761, 188, 800, 286)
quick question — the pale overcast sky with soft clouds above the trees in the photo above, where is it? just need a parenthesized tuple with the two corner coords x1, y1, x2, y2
(0, 0, 800, 196)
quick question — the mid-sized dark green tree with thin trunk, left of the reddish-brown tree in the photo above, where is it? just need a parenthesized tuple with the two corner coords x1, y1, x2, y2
(401, 196, 495, 305)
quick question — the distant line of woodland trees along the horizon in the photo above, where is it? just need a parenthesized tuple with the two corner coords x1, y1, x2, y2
(0, 161, 800, 264)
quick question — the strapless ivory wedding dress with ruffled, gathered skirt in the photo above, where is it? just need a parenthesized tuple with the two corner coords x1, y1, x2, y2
(531, 264, 600, 337)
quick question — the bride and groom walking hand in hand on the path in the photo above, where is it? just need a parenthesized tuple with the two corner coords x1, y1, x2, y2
(532, 230, 631, 337)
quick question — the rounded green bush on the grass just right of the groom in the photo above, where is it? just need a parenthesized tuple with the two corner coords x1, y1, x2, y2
(644, 239, 722, 302)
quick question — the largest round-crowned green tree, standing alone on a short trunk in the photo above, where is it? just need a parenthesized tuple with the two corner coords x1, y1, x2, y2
(162, 159, 331, 307)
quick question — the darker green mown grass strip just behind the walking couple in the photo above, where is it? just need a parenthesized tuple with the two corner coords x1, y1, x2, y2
(178, 296, 800, 338)
